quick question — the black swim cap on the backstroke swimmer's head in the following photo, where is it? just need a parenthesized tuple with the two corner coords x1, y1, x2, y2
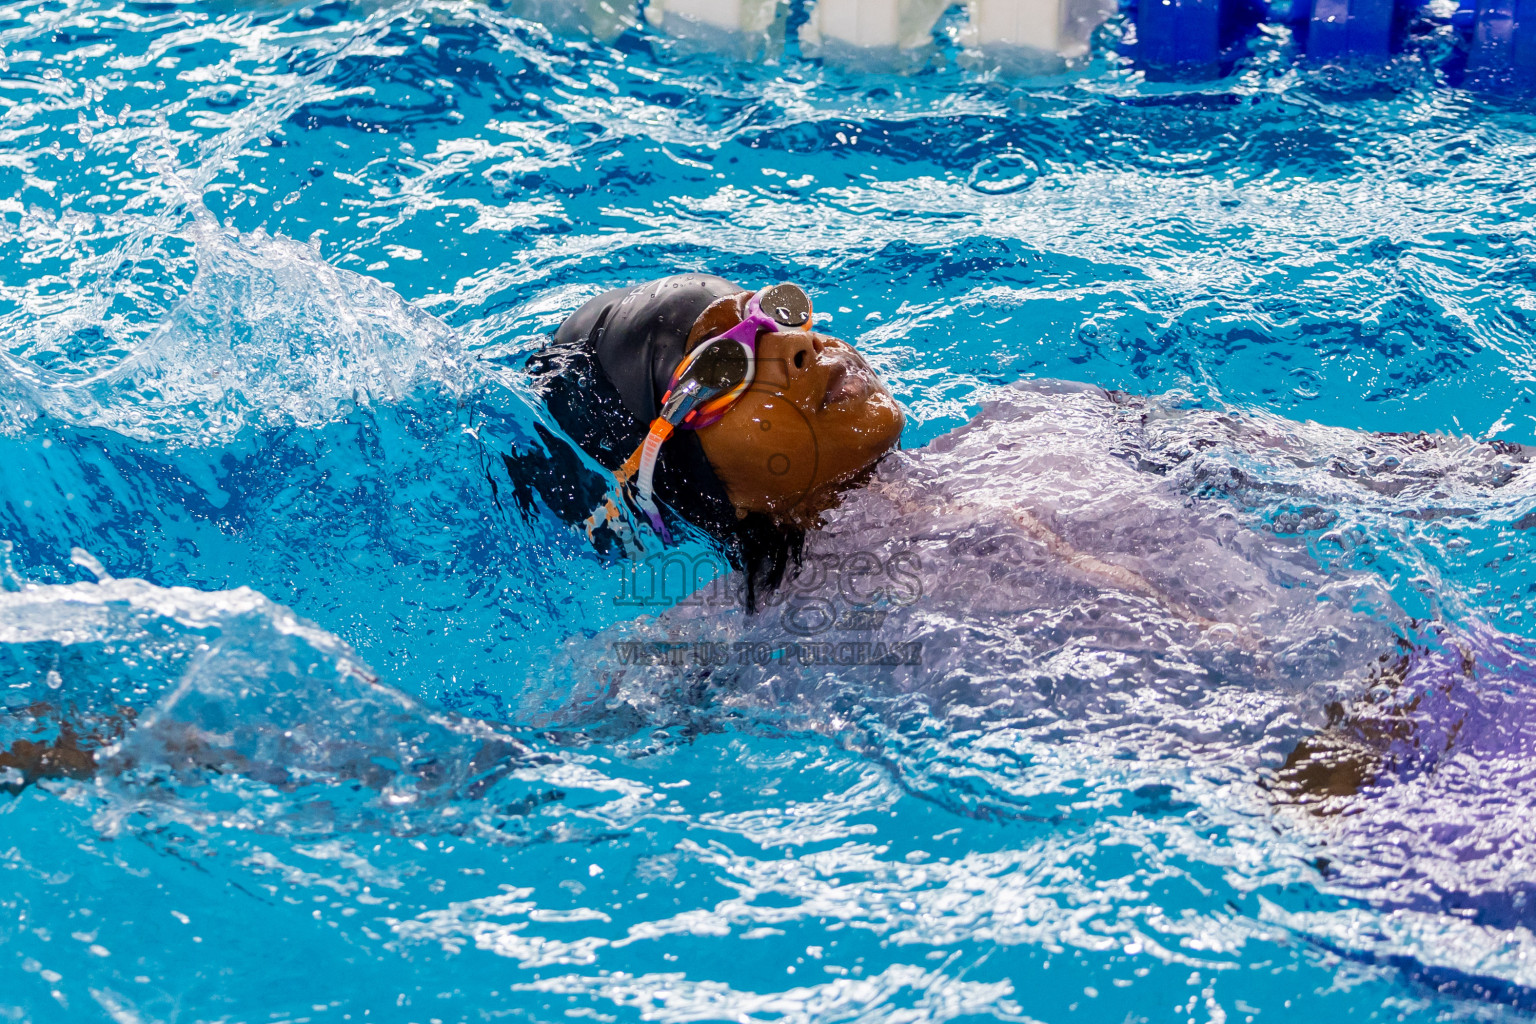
(505, 273, 805, 608)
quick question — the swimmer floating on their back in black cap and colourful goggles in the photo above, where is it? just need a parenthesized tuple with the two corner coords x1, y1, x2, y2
(505, 275, 1527, 806)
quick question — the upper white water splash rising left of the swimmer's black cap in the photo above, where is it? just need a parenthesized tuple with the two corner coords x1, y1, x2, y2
(0, 218, 464, 445)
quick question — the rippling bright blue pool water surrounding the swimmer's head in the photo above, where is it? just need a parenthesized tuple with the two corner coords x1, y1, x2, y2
(0, 0, 1536, 1024)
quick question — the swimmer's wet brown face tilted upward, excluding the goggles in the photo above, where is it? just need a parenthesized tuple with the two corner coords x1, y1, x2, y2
(688, 292, 906, 524)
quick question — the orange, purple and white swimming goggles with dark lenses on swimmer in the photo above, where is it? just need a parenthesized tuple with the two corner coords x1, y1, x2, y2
(587, 284, 811, 543)
